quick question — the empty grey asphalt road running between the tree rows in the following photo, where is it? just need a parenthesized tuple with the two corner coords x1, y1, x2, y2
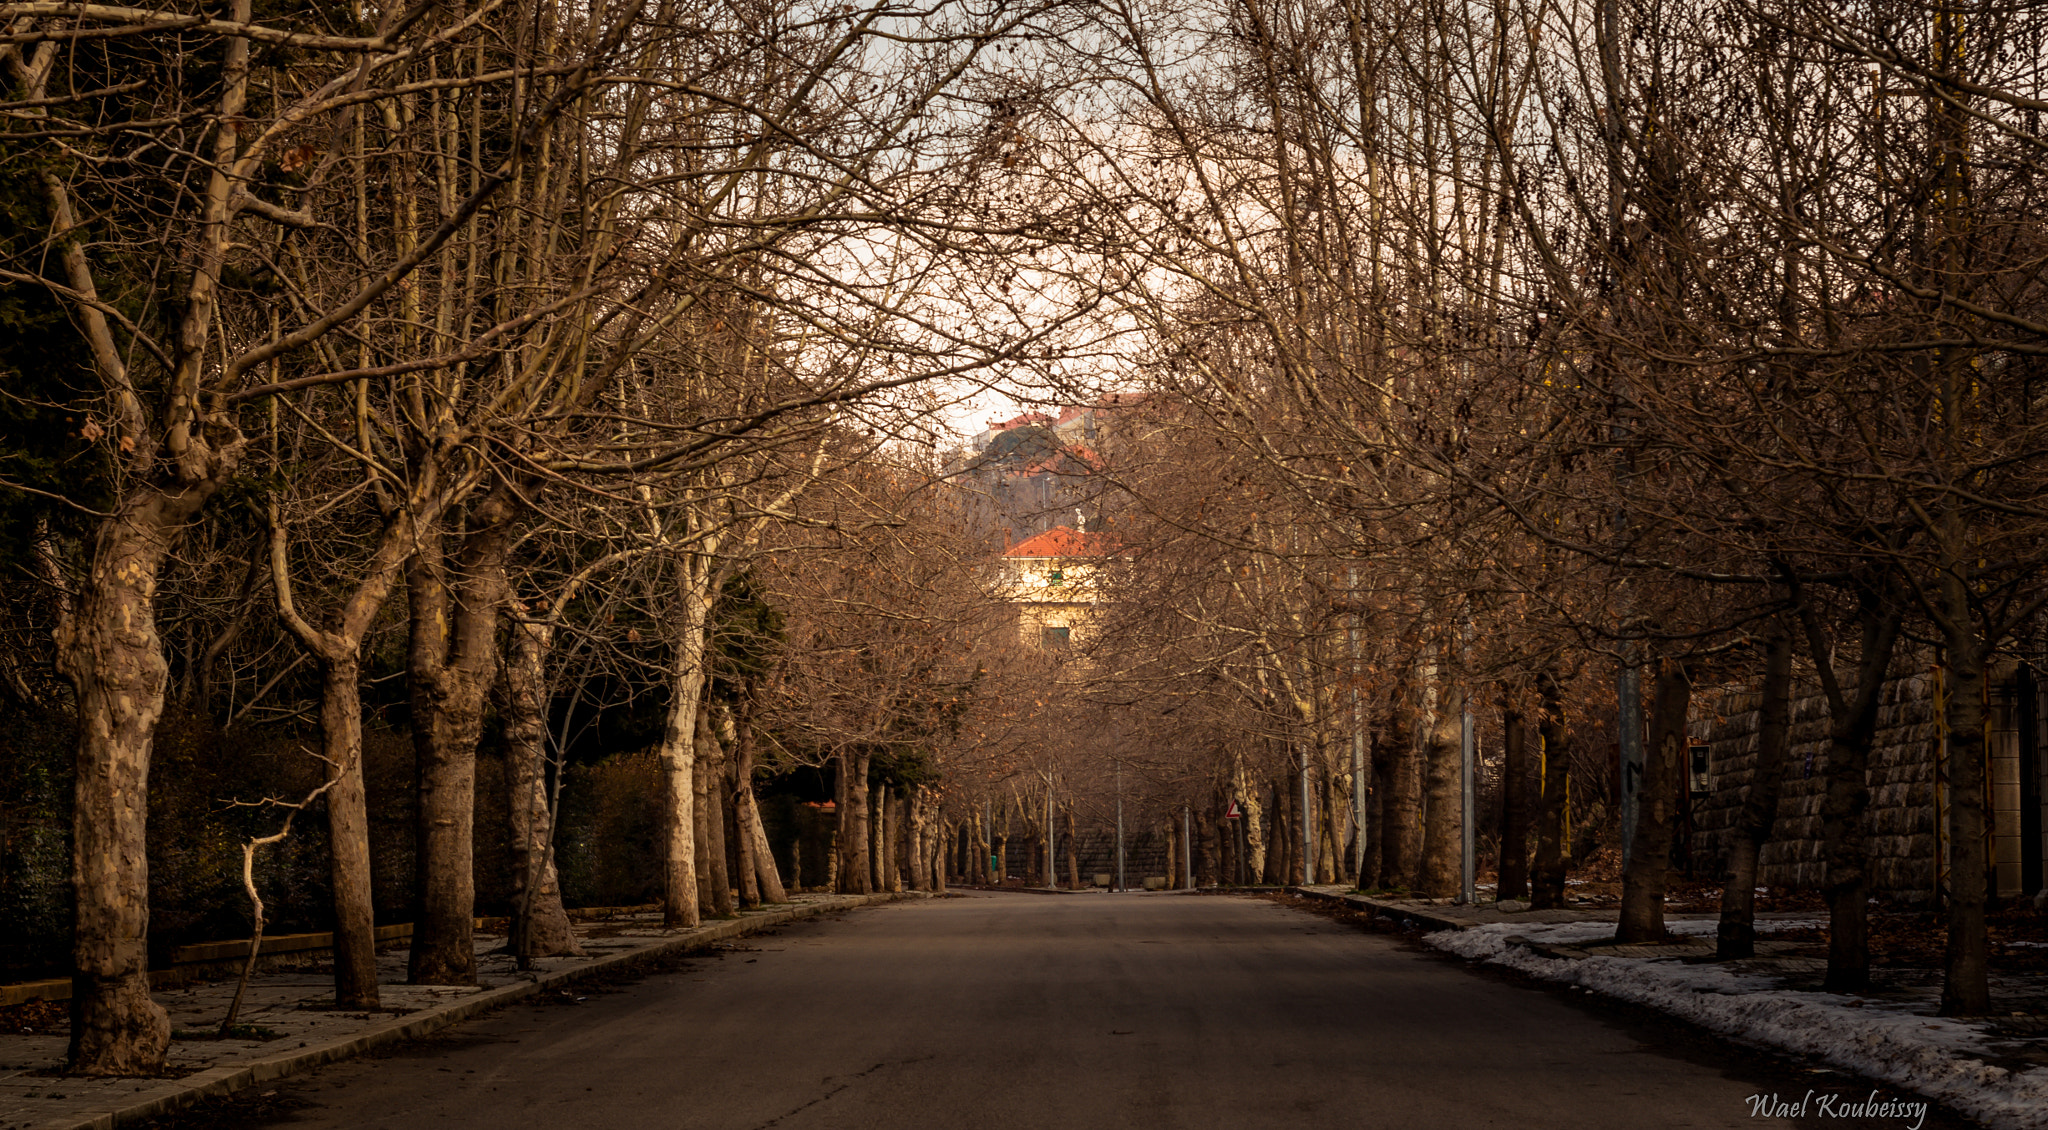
(163, 895, 1968, 1130)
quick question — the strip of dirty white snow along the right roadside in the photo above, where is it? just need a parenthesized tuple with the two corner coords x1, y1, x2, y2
(1423, 919, 2048, 1130)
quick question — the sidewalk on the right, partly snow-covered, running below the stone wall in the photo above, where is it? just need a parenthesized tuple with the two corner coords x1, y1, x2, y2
(1290, 886, 2048, 1130)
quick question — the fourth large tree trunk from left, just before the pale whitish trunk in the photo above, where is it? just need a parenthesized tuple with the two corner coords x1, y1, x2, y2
(504, 624, 582, 960)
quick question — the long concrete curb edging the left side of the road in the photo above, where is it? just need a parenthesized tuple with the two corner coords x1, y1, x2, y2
(41, 890, 926, 1130)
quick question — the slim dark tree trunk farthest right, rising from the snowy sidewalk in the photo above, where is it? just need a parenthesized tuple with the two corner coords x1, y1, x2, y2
(1942, 626, 1991, 1015)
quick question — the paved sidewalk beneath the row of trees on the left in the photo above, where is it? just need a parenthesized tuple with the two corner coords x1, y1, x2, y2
(0, 893, 924, 1130)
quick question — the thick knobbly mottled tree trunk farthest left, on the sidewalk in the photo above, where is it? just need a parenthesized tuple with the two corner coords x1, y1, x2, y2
(57, 499, 195, 1075)
